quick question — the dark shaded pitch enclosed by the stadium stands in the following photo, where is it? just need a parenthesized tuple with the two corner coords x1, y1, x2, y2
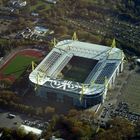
(62, 56, 98, 83)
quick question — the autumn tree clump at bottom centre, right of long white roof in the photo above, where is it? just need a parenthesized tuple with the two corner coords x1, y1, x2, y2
(44, 110, 94, 140)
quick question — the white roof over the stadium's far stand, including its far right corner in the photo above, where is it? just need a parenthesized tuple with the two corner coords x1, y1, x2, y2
(56, 40, 122, 60)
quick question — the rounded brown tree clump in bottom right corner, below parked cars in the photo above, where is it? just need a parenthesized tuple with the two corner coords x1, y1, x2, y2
(96, 118, 134, 140)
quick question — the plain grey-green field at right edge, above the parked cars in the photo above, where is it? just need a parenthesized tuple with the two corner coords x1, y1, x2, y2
(122, 72, 140, 113)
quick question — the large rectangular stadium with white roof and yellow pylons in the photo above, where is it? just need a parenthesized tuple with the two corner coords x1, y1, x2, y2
(29, 40, 124, 108)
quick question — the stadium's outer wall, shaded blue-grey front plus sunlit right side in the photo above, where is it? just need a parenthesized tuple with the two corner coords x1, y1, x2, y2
(32, 62, 123, 108)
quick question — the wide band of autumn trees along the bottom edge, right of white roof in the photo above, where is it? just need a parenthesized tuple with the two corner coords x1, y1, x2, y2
(42, 110, 140, 140)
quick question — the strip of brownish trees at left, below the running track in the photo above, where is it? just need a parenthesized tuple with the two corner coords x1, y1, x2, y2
(0, 91, 55, 118)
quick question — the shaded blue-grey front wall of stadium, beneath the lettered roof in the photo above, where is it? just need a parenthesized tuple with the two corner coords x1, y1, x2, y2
(33, 83, 104, 108)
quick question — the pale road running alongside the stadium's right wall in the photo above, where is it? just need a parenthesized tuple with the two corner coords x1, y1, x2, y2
(97, 64, 132, 123)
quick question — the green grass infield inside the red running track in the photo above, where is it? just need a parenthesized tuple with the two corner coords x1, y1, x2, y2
(2, 55, 37, 79)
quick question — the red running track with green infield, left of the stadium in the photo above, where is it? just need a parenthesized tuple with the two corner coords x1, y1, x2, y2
(0, 49, 42, 81)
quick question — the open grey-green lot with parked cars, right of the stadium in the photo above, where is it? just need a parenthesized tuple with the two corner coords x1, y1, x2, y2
(97, 65, 140, 126)
